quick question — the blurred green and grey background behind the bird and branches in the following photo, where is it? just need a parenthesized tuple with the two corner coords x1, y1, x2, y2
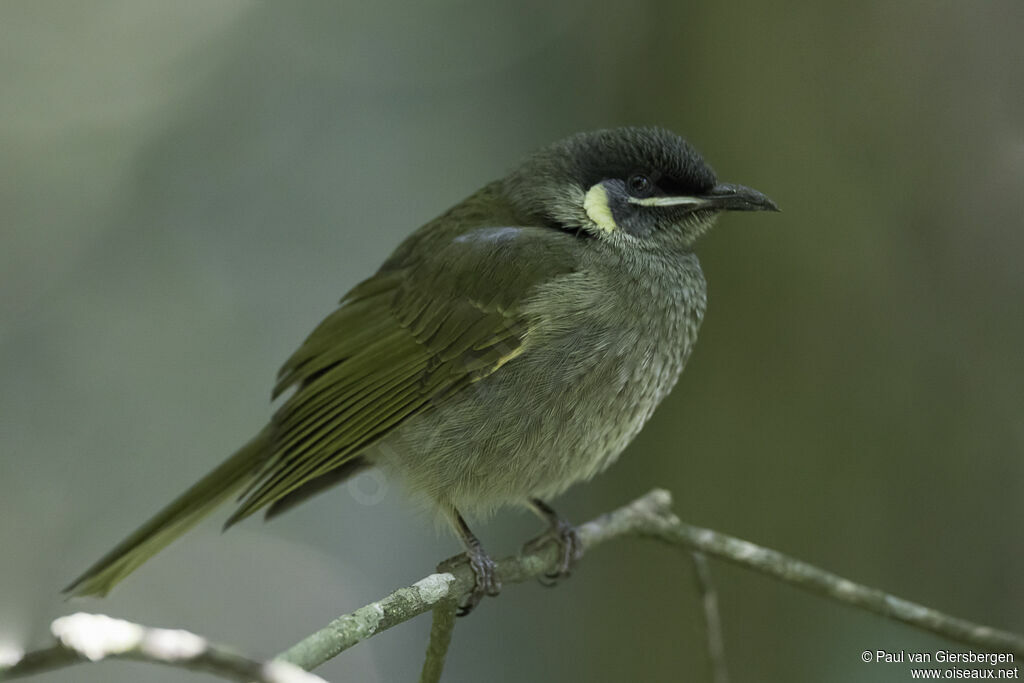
(0, 0, 1024, 682)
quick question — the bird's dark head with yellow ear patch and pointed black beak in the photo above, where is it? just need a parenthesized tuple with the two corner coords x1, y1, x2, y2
(504, 128, 778, 249)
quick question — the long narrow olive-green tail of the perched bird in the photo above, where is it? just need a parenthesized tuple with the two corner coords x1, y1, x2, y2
(63, 429, 267, 596)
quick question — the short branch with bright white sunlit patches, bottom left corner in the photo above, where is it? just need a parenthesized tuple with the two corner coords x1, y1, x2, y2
(0, 612, 326, 683)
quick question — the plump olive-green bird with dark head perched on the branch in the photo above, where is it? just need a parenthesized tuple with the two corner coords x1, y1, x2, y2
(65, 127, 778, 614)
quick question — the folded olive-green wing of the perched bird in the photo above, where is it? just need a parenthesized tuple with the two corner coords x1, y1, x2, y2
(227, 226, 574, 525)
